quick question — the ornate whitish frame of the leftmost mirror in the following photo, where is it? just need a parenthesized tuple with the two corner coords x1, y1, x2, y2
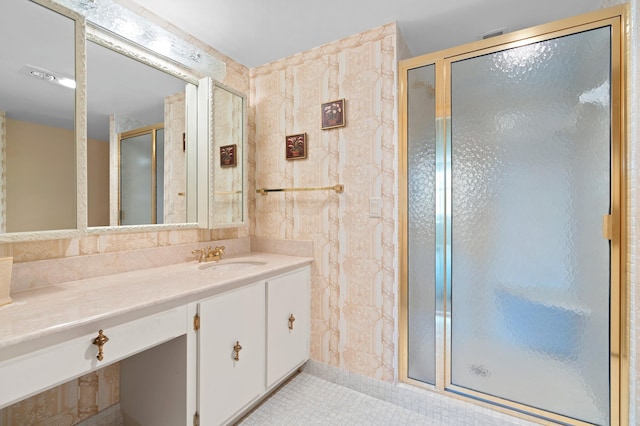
(0, 0, 87, 243)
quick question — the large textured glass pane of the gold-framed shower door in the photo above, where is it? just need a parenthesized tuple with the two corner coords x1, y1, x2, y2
(450, 27, 611, 424)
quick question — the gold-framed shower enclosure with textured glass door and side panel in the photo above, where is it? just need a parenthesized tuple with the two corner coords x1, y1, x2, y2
(400, 8, 625, 425)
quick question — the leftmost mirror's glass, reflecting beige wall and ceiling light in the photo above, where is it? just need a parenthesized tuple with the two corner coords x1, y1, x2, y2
(0, 0, 78, 233)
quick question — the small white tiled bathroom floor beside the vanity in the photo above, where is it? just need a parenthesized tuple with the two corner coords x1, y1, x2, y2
(237, 372, 448, 426)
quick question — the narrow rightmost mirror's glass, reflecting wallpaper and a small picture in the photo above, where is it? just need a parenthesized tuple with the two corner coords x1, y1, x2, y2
(209, 84, 246, 227)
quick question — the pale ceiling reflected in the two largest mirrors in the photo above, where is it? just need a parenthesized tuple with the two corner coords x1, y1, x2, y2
(0, 0, 186, 141)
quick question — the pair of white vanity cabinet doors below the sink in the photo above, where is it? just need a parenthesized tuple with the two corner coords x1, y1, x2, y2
(198, 266, 310, 426)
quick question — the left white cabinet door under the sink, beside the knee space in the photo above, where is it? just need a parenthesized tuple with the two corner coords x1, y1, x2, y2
(198, 282, 265, 425)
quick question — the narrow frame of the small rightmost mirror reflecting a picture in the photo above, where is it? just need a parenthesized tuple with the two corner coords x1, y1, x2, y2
(207, 80, 249, 229)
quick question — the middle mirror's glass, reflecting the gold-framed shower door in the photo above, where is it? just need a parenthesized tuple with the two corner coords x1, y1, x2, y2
(87, 41, 197, 227)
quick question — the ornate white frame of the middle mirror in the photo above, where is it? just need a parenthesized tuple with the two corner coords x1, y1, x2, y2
(86, 22, 208, 235)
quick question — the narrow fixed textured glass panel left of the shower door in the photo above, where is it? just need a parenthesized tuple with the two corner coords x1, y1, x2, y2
(407, 65, 436, 384)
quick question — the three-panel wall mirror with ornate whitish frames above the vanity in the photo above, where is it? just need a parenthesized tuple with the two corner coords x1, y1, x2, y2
(0, 0, 247, 242)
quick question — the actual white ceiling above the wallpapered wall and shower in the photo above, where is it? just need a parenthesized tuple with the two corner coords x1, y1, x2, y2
(129, 0, 602, 68)
